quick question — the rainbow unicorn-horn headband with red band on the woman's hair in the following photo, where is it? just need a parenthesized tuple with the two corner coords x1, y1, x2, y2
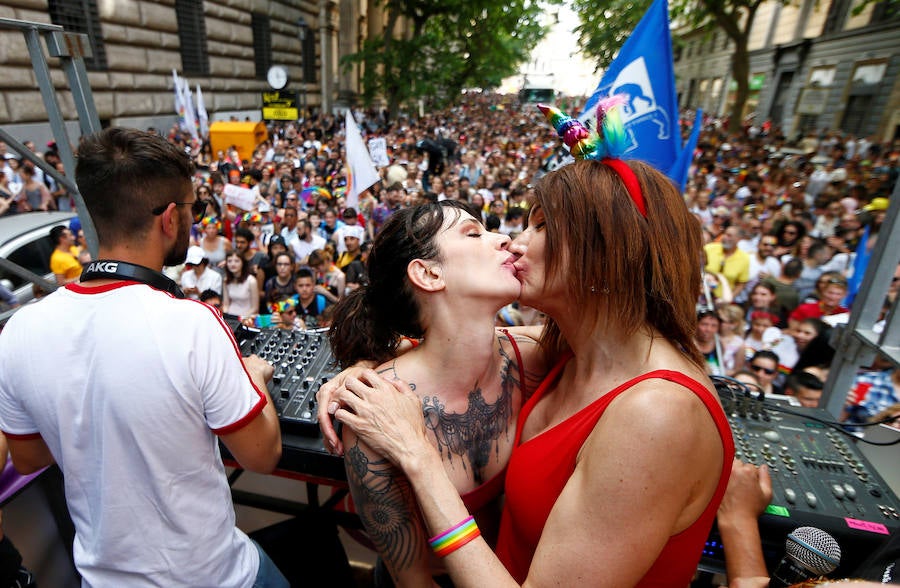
(538, 99, 647, 218)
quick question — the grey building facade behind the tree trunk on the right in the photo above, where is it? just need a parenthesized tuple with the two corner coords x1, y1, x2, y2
(675, 0, 900, 140)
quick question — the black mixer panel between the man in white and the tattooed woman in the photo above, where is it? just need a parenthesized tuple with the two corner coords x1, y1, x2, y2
(235, 329, 340, 437)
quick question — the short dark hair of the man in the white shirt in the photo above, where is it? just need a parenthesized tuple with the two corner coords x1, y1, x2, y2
(75, 127, 194, 246)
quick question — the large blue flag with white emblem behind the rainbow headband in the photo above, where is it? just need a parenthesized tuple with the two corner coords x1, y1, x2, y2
(579, 0, 681, 173)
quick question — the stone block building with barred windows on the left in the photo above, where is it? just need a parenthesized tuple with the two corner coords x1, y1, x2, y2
(0, 0, 383, 144)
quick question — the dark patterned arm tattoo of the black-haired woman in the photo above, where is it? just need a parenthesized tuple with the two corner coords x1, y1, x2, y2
(344, 443, 425, 570)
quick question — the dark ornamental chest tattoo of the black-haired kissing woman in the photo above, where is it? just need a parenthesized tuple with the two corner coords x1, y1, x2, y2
(422, 346, 519, 484)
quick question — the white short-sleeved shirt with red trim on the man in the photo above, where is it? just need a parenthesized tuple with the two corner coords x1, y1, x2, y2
(0, 282, 266, 588)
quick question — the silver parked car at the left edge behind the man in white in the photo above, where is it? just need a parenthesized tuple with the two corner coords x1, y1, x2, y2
(0, 212, 76, 310)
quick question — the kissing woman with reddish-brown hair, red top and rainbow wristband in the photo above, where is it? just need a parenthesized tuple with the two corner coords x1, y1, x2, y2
(335, 103, 734, 586)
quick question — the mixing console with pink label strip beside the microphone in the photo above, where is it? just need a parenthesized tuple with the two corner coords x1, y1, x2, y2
(704, 382, 900, 577)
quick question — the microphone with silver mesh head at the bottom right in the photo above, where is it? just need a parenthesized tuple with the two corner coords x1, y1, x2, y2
(769, 527, 841, 588)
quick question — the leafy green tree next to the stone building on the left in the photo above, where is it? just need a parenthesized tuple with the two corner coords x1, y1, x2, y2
(345, 0, 560, 117)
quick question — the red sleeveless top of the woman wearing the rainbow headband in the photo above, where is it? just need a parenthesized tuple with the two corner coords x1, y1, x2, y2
(497, 356, 734, 586)
